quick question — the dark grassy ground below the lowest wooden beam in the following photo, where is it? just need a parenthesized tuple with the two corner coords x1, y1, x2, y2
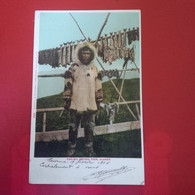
(35, 130, 141, 158)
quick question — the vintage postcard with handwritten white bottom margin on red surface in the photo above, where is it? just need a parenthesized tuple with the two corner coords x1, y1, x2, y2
(29, 10, 145, 185)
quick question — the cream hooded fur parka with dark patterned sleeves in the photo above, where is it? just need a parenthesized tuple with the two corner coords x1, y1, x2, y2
(63, 42, 103, 112)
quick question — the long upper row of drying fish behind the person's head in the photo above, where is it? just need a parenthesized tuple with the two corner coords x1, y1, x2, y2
(38, 28, 139, 68)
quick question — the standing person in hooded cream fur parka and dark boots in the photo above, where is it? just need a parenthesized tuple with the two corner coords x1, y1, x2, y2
(63, 42, 103, 156)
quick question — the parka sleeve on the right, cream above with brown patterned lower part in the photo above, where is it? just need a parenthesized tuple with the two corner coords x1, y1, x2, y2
(95, 73, 103, 102)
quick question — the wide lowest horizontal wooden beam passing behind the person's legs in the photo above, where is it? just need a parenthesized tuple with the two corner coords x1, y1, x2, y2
(35, 121, 141, 142)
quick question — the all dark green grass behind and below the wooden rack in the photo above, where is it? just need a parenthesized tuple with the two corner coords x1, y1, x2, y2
(35, 78, 141, 158)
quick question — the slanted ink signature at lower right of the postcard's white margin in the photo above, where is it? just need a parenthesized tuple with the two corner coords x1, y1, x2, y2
(83, 166, 135, 183)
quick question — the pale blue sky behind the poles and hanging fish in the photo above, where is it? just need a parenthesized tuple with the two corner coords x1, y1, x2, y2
(36, 10, 140, 97)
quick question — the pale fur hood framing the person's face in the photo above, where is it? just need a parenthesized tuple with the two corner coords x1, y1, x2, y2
(74, 42, 97, 67)
